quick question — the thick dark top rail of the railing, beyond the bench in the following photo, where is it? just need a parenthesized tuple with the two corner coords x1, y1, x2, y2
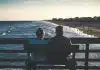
(0, 38, 100, 44)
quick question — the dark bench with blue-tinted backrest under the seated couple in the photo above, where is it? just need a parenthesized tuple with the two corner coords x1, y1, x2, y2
(24, 39, 79, 70)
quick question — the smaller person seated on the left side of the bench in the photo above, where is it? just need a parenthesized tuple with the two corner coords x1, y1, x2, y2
(29, 28, 44, 70)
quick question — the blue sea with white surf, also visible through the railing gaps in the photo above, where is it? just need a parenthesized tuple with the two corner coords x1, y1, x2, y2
(0, 21, 100, 70)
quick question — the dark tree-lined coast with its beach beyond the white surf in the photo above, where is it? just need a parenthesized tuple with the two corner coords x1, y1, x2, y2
(46, 16, 100, 37)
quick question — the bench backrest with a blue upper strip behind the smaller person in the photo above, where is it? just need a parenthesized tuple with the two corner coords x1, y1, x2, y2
(24, 39, 79, 52)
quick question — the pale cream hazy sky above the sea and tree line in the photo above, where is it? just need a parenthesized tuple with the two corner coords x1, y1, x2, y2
(0, 0, 100, 20)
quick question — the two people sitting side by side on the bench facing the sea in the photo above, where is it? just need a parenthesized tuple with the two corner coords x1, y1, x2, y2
(27, 26, 77, 69)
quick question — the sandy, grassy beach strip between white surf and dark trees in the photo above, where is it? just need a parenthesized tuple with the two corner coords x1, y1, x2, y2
(46, 20, 100, 37)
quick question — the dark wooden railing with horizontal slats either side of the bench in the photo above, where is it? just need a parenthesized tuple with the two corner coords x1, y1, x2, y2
(0, 38, 100, 70)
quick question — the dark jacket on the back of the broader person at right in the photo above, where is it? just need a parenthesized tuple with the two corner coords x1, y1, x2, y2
(46, 36, 71, 63)
